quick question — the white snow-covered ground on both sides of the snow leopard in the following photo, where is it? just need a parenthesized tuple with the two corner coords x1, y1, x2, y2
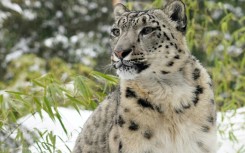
(15, 107, 245, 153)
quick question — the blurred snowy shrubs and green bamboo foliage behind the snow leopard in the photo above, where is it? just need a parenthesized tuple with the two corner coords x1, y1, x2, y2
(0, 0, 245, 152)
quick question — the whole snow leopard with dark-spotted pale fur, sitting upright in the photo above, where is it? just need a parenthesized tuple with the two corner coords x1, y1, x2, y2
(73, 0, 216, 153)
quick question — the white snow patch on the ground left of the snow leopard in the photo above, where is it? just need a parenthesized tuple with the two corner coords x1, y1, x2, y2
(18, 108, 92, 153)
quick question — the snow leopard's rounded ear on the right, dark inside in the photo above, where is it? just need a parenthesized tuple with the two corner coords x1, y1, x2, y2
(164, 0, 187, 34)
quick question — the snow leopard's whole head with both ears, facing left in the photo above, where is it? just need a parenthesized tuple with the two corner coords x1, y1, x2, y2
(111, 1, 187, 79)
